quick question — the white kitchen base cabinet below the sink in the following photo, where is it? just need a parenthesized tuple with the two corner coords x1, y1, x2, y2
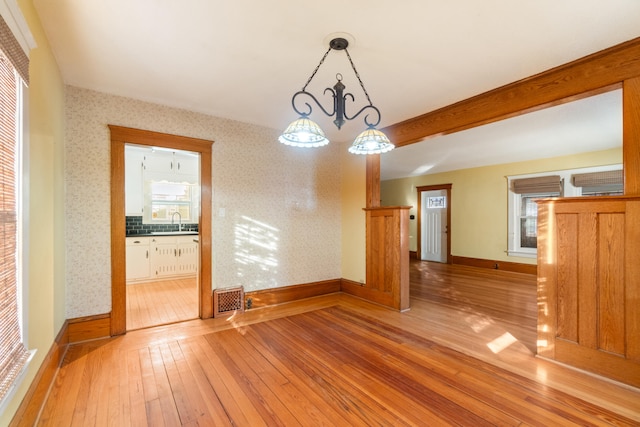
(151, 235, 198, 278)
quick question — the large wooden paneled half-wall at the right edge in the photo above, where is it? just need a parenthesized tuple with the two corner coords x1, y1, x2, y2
(538, 196, 640, 387)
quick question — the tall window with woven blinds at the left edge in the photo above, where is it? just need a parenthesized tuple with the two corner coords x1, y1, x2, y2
(0, 18, 30, 401)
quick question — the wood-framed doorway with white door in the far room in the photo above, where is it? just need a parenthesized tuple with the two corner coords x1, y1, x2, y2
(416, 184, 452, 264)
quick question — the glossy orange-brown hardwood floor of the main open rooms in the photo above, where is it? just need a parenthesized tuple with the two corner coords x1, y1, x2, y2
(33, 262, 640, 426)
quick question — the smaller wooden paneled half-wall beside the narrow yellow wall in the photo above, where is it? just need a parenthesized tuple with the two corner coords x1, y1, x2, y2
(343, 206, 411, 310)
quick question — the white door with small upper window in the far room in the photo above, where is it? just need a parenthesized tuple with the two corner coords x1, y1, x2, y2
(420, 190, 449, 263)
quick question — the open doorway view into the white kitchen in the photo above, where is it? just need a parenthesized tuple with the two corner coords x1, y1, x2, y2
(125, 144, 200, 331)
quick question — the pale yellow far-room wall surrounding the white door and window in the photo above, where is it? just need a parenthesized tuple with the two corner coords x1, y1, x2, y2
(380, 148, 622, 264)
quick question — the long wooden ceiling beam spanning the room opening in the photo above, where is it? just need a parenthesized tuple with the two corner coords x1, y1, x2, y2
(382, 38, 640, 147)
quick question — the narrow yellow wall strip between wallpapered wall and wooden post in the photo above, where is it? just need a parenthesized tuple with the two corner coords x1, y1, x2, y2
(341, 150, 367, 283)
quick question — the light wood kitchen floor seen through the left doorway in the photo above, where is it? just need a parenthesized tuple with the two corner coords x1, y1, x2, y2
(127, 276, 198, 331)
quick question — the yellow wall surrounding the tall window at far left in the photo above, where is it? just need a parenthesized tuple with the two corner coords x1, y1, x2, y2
(0, 0, 66, 425)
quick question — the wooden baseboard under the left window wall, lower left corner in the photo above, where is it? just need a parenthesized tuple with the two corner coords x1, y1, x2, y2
(9, 321, 69, 427)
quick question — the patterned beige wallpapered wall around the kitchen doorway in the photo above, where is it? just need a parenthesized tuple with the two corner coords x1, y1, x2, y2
(65, 86, 341, 318)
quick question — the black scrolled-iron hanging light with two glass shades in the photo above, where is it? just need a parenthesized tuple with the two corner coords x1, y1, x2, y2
(278, 37, 395, 154)
